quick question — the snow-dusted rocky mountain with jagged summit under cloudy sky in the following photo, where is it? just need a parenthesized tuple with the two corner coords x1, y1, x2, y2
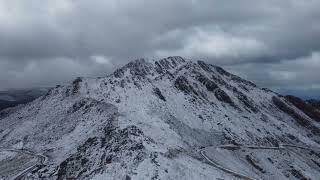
(0, 57, 320, 180)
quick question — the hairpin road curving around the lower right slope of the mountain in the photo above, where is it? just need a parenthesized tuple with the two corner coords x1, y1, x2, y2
(199, 144, 320, 180)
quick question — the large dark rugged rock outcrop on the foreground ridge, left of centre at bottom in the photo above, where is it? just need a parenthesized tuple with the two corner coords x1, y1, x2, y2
(53, 125, 146, 179)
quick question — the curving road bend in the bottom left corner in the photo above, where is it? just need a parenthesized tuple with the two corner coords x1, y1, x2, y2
(0, 148, 48, 180)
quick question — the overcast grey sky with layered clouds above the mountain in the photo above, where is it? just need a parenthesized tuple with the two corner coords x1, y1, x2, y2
(0, 0, 320, 97)
